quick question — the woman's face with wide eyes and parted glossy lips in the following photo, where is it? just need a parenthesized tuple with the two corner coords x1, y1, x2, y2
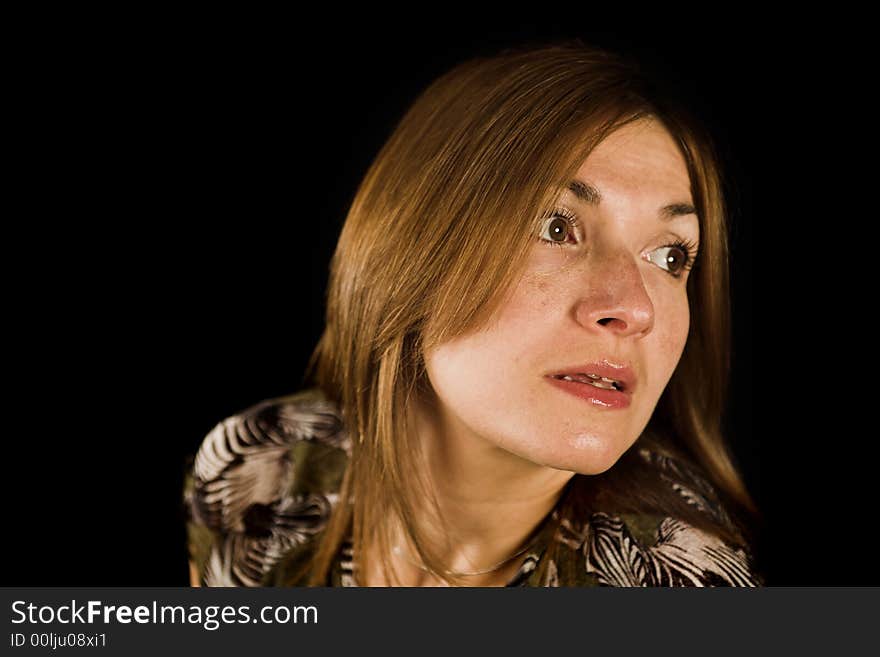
(426, 120, 700, 474)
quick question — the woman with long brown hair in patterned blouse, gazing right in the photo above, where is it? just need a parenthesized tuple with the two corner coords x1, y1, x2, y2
(185, 41, 763, 586)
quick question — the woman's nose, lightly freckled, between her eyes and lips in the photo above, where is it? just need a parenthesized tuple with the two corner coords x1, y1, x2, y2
(575, 251, 654, 337)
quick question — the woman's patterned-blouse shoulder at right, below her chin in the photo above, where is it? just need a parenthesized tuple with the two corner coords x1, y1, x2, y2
(545, 448, 764, 586)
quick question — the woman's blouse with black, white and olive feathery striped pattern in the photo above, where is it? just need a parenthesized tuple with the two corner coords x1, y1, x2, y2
(183, 388, 764, 586)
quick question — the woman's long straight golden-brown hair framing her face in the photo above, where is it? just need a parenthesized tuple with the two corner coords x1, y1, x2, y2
(294, 39, 757, 586)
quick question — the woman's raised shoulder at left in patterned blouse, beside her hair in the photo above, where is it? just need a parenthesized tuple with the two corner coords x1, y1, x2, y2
(184, 388, 351, 586)
